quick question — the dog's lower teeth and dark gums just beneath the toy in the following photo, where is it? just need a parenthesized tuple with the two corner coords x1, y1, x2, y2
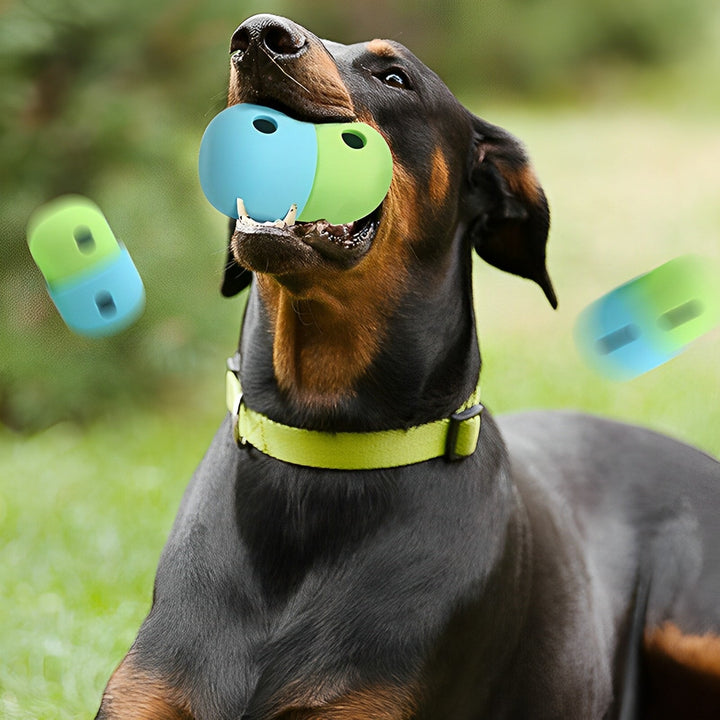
(234, 198, 382, 269)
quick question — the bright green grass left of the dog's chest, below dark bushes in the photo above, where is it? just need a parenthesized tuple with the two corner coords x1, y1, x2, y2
(0, 408, 222, 720)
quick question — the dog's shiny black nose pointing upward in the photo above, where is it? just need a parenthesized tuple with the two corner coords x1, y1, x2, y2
(230, 15, 308, 62)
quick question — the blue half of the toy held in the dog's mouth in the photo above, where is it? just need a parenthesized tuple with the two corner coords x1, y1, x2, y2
(198, 103, 318, 222)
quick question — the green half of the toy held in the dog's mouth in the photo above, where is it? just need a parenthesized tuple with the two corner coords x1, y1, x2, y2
(298, 122, 393, 225)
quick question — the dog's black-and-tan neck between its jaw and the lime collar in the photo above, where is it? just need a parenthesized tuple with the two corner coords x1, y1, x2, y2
(240, 242, 480, 431)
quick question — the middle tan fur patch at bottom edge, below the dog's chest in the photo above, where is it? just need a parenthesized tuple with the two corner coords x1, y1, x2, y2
(273, 685, 417, 720)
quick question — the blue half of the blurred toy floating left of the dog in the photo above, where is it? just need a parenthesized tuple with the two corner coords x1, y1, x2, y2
(48, 246, 145, 337)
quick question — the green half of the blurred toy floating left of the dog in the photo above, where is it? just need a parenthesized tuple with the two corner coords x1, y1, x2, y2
(28, 195, 120, 285)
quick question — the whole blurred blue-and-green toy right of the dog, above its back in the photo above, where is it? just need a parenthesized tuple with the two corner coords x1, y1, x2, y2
(575, 255, 720, 380)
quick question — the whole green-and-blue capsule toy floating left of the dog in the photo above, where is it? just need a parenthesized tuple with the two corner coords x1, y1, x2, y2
(28, 195, 145, 337)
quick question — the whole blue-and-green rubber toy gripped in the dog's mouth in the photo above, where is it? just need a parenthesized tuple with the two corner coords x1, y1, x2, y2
(199, 103, 392, 225)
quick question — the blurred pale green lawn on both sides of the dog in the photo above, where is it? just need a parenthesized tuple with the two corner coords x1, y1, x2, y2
(0, 108, 720, 720)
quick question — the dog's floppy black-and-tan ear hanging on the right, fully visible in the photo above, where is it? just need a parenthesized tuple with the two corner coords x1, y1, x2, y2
(468, 117, 557, 308)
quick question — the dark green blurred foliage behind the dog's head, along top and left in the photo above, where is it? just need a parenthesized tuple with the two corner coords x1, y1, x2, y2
(0, 0, 719, 430)
